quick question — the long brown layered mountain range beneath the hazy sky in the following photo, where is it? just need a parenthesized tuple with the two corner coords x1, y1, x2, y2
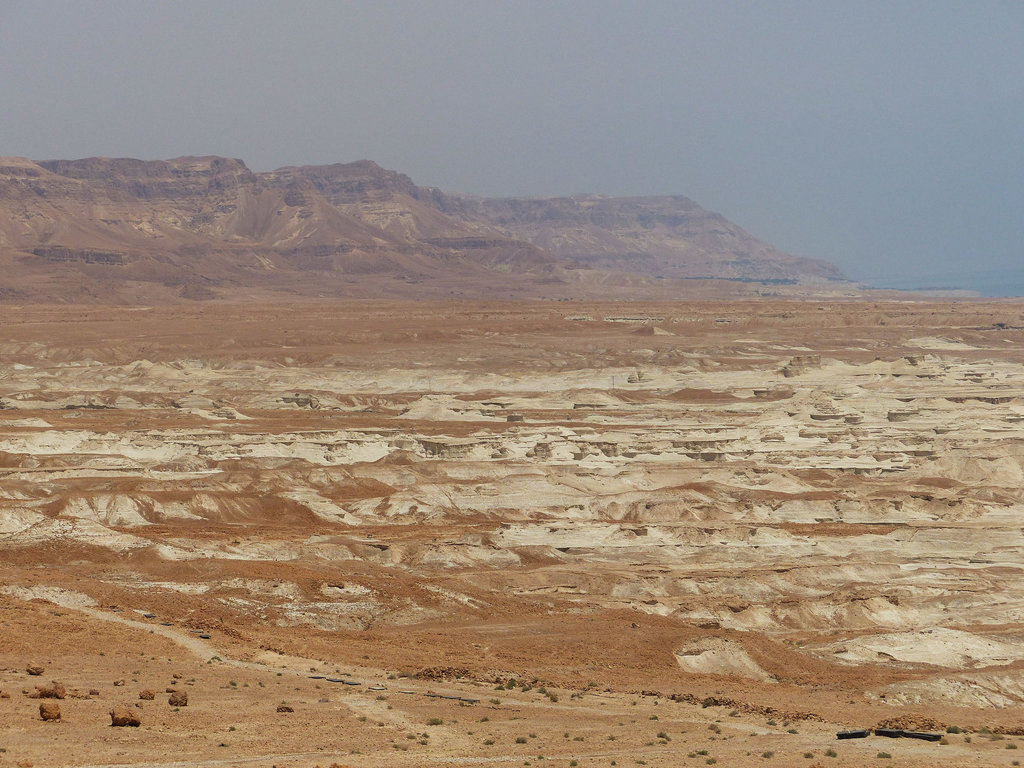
(0, 157, 840, 301)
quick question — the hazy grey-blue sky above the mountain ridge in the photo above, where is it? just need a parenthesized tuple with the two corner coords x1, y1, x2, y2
(0, 0, 1024, 281)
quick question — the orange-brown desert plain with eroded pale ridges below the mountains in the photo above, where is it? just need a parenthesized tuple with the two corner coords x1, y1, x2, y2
(0, 298, 1024, 768)
